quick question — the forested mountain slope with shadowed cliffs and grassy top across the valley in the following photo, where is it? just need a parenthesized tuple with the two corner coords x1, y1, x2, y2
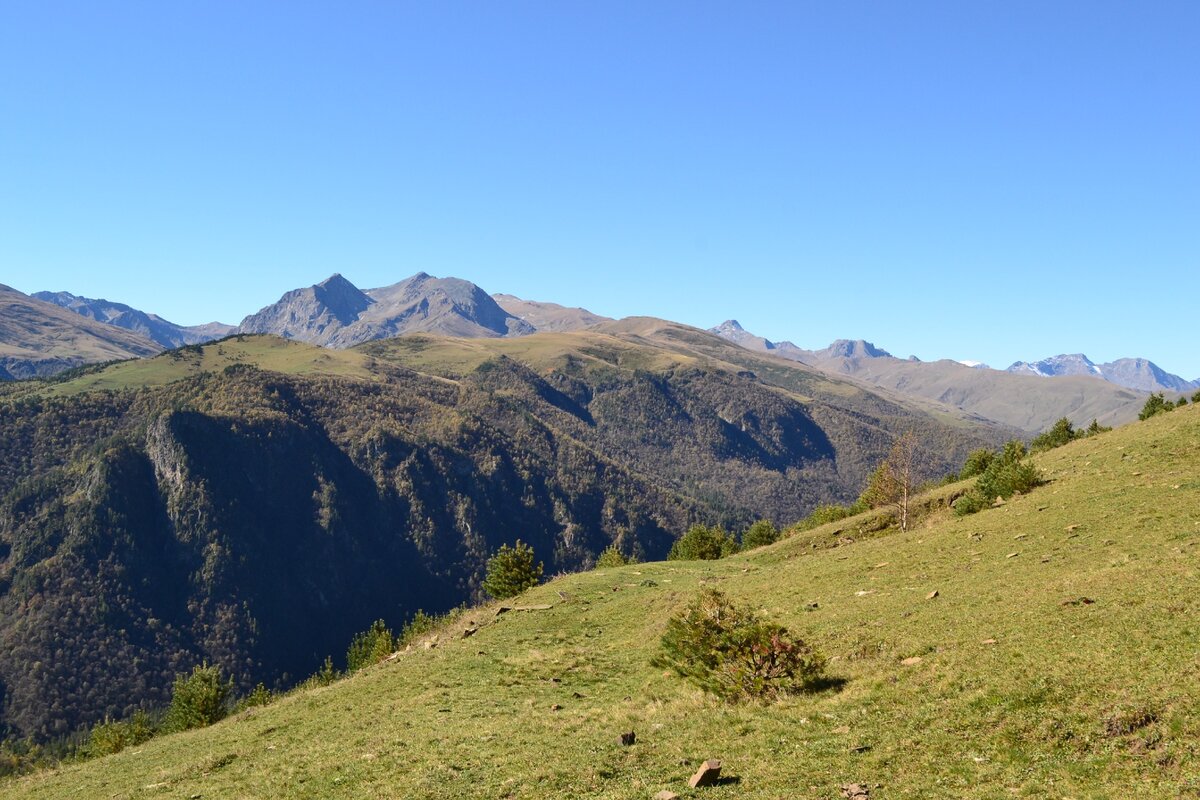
(0, 328, 1004, 736)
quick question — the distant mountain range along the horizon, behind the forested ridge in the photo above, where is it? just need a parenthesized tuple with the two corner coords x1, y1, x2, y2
(0, 272, 1200, 441)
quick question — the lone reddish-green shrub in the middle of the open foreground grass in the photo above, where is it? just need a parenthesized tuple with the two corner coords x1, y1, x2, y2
(652, 589, 824, 703)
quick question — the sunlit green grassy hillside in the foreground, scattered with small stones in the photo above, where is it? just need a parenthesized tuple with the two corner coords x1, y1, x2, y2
(0, 407, 1200, 799)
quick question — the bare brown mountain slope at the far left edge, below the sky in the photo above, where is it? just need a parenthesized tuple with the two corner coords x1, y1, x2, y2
(0, 284, 162, 380)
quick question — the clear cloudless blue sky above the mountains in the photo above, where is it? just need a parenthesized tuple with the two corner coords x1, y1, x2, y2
(0, 0, 1200, 379)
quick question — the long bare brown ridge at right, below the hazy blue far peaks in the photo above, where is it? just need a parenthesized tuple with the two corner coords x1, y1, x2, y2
(712, 320, 1146, 433)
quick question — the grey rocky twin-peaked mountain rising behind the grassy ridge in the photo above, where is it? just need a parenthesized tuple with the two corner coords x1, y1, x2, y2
(239, 272, 534, 348)
